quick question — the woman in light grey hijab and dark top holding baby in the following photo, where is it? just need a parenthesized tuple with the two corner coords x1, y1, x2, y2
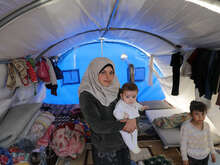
(79, 57, 136, 165)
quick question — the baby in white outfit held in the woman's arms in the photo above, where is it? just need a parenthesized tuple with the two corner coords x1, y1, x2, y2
(113, 83, 148, 154)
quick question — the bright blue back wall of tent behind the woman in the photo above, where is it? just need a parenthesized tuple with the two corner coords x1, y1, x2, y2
(44, 43, 165, 104)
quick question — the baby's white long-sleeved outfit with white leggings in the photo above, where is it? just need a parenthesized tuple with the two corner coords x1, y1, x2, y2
(113, 100, 143, 154)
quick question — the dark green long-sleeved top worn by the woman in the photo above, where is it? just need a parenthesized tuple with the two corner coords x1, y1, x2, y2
(79, 91, 125, 152)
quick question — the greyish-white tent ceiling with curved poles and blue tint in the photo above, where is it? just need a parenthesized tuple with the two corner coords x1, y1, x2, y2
(0, 0, 220, 59)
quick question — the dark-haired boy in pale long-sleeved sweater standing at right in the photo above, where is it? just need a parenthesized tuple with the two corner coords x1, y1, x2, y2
(180, 101, 216, 165)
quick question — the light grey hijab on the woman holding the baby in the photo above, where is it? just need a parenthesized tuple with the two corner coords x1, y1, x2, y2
(78, 57, 120, 106)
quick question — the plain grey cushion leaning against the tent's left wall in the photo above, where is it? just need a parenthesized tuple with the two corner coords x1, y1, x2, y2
(0, 103, 41, 148)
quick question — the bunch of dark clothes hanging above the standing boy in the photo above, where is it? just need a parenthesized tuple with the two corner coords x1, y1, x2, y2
(187, 48, 220, 100)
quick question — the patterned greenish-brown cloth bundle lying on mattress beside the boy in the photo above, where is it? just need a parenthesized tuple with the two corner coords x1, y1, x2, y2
(153, 112, 190, 128)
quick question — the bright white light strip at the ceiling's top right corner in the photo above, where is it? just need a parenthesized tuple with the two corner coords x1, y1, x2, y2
(186, 0, 220, 13)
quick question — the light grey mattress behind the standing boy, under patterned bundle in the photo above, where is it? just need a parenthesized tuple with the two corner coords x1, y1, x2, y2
(145, 108, 220, 149)
